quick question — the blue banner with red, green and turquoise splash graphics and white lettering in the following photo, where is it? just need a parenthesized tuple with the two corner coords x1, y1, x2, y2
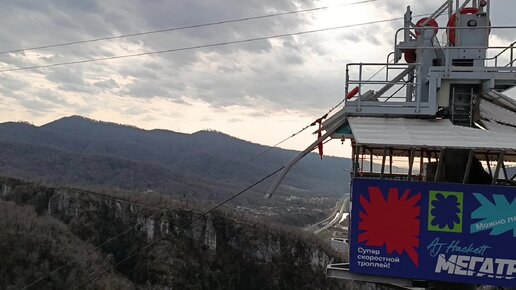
(349, 178, 516, 287)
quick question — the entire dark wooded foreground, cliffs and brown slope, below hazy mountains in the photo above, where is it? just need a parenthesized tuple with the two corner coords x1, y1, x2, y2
(0, 178, 346, 290)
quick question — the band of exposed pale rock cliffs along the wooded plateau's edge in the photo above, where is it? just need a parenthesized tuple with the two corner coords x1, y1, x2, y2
(46, 188, 333, 269)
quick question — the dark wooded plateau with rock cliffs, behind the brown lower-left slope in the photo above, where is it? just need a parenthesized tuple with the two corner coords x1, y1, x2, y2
(1, 179, 345, 289)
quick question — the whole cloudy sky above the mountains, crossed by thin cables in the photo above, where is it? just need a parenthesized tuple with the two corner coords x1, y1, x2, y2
(0, 0, 516, 155)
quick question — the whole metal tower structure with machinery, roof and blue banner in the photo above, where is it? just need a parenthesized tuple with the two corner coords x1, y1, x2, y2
(267, 0, 516, 289)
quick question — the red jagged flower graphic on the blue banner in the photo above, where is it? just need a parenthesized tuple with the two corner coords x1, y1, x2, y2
(358, 187, 421, 266)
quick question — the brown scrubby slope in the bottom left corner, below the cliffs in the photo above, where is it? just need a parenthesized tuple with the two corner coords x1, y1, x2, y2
(0, 200, 133, 289)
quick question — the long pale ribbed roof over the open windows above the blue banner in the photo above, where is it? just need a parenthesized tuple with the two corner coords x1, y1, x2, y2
(348, 117, 516, 153)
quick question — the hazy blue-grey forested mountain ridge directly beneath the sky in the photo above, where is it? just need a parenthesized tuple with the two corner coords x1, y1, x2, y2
(0, 116, 350, 202)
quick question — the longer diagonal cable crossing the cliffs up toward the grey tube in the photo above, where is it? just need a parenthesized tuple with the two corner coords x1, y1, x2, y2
(74, 166, 285, 290)
